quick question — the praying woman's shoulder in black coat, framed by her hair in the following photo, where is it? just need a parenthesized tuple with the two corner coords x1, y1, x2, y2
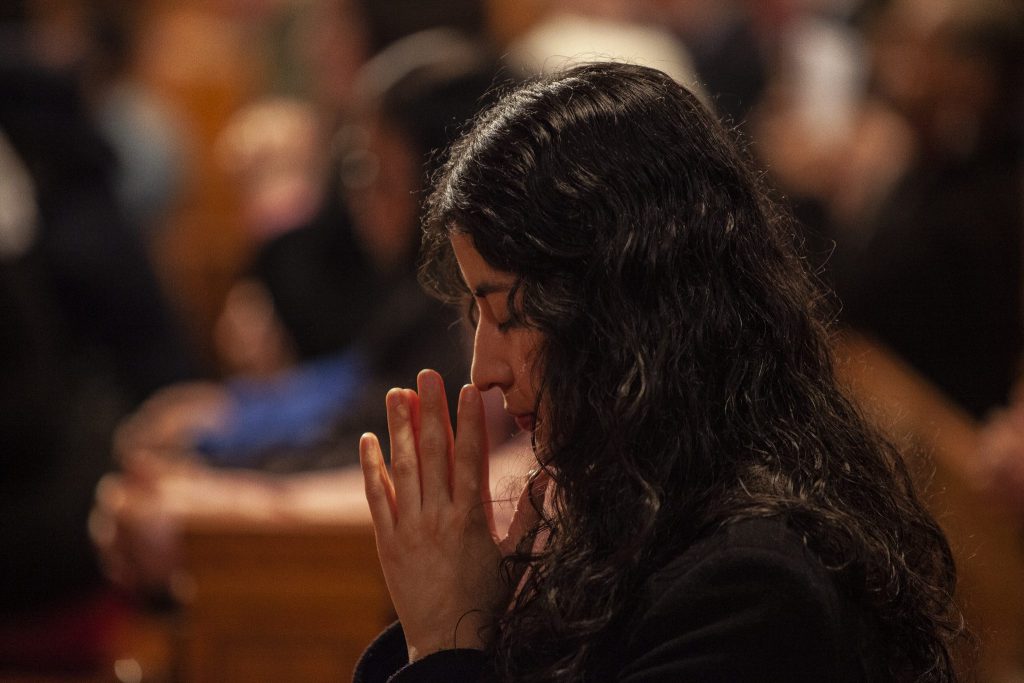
(622, 518, 865, 682)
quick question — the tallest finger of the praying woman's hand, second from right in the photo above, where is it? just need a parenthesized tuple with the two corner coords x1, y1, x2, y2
(417, 370, 454, 506)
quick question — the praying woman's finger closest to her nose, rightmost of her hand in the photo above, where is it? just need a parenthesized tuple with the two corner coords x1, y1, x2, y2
(452, 384, 493, 518)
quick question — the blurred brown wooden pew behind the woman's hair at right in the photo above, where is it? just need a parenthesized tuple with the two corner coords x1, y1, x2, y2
(837, 334, 1024, 683)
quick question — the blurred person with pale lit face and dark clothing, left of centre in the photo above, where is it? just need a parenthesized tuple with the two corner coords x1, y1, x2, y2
(214, 97, 337, 377)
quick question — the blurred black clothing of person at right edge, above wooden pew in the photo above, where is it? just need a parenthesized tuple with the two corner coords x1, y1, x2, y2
(833, 138, 1024, 417)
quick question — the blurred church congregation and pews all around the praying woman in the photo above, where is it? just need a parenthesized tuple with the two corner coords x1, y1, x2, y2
(0, 0, 1024, 683)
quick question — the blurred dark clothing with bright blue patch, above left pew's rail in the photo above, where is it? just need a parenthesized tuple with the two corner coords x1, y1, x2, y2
(197, 274, 469, 472)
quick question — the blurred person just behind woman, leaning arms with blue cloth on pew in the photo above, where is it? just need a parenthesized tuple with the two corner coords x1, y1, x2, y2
(93, 30, 510, 592)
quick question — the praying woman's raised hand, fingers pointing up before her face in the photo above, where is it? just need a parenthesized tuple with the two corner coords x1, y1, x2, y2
(359, 370, 509, 661)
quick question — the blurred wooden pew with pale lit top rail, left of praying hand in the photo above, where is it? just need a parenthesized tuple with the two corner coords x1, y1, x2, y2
(161, 438, 532, 683)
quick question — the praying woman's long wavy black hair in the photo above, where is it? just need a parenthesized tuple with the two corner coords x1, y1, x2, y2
(421, 63, 961, 681)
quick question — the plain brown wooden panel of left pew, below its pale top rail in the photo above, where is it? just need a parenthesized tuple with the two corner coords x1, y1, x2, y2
(174, 519, 394, 683)
